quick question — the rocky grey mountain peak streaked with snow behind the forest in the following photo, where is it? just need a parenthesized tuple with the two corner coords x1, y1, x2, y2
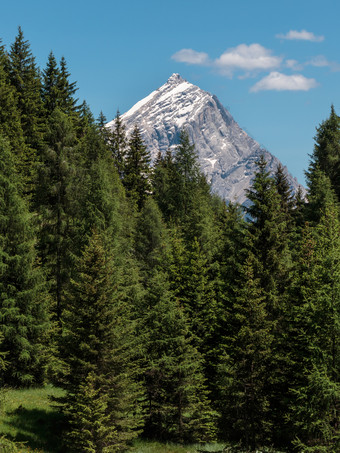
(107, 74, 299, 203)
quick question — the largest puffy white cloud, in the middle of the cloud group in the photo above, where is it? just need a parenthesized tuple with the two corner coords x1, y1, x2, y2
(213, 44, 282, 76)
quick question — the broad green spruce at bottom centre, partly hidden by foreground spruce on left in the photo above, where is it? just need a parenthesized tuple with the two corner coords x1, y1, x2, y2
(143, 272, 216, 442)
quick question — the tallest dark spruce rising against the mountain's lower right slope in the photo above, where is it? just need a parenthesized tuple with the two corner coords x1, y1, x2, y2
(247, 155, 291, 442)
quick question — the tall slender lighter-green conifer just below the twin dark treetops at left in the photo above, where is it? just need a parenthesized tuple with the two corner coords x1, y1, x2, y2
(35, 109, 77, 321)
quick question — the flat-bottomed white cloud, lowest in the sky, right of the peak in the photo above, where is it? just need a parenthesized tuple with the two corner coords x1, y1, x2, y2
(250, 72, 318, 93)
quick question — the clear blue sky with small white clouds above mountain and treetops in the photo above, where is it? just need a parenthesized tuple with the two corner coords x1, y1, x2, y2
(0, 0, 340, 183)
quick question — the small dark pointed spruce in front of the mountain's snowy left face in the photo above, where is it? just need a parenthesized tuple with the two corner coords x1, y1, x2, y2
(123, 126, 151, 209)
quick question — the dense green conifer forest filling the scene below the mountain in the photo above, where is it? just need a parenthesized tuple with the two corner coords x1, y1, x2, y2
(0, 28, 340, 452)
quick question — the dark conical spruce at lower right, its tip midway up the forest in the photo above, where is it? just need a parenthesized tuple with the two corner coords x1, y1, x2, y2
(219, 252, 273, 451)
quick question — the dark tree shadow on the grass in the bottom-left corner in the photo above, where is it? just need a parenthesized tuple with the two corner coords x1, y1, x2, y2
(5, 406, 65, 453)
